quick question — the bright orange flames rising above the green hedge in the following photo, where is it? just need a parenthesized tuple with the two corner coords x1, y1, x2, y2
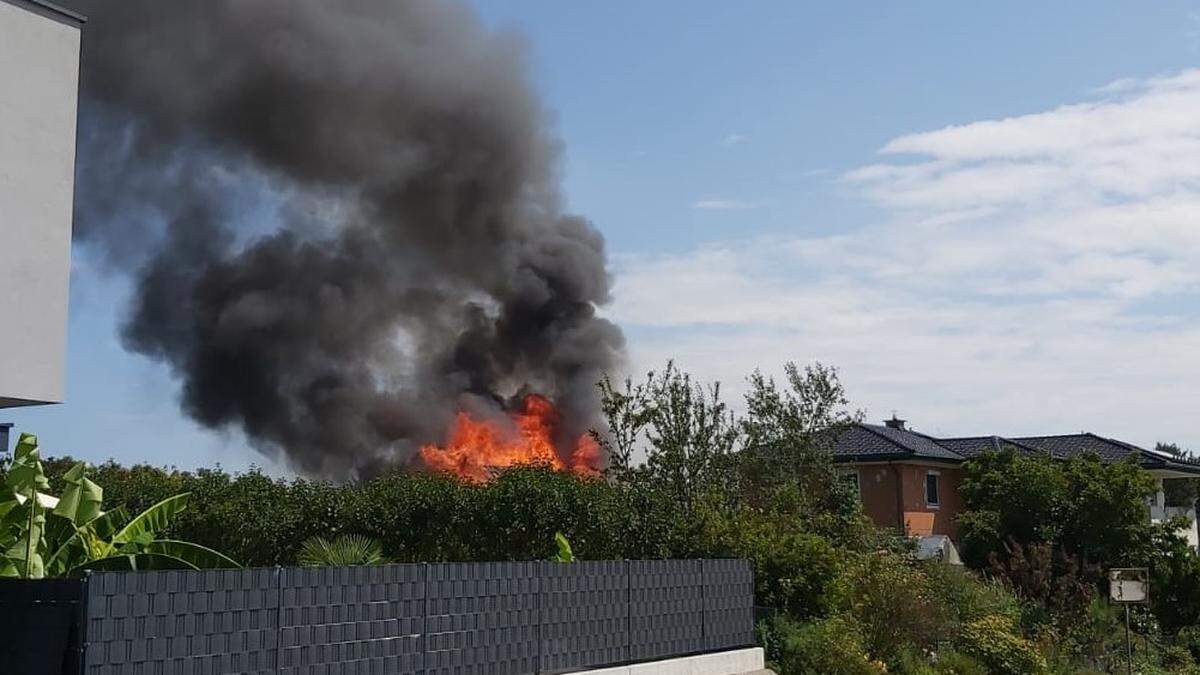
(420, 394, 600, 483)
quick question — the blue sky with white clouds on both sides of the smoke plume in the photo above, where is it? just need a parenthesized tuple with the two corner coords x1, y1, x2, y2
(4, 1, 1200, 471)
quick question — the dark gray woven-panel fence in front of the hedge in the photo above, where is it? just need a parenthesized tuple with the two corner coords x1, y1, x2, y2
(0, 560, 754, 675)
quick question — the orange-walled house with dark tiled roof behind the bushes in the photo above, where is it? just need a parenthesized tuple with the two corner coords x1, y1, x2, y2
(833, 416, 1200, 546)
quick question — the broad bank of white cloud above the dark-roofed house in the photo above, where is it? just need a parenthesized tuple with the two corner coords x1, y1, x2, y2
(611, 71, 1200, 448)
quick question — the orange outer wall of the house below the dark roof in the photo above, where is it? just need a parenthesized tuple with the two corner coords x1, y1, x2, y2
(857, 464, 962, 539)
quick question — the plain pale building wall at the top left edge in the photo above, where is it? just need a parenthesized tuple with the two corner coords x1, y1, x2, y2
(0, 0, 80, 407)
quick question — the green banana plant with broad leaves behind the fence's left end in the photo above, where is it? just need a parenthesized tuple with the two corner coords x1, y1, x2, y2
(0, 434, 240, 571)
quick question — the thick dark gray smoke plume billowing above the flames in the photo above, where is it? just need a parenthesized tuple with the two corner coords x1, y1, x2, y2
(63, 0, 624, 478)
